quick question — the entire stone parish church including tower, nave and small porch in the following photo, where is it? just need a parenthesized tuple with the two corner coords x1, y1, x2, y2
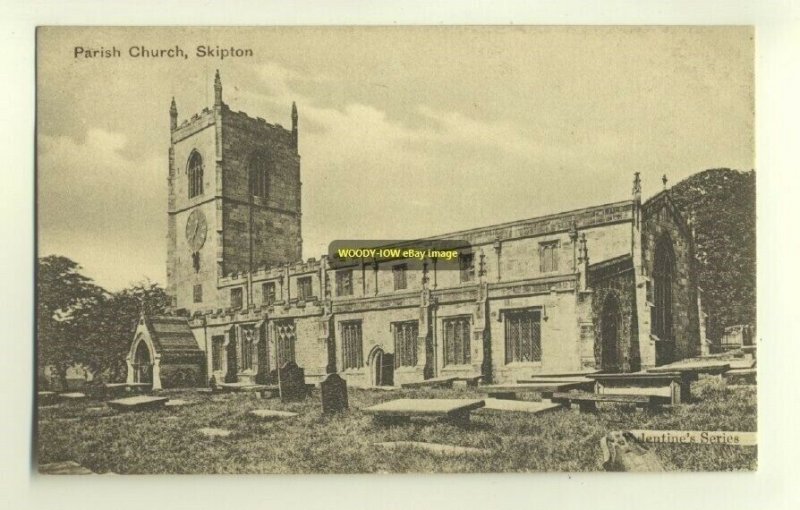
(128, 73, 701, 389)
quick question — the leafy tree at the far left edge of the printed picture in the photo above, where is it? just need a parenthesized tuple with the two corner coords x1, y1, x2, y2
(36, 255, 105, 386)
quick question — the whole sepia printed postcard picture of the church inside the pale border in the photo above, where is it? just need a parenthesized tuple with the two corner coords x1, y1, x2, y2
(32, 26, 760, 476)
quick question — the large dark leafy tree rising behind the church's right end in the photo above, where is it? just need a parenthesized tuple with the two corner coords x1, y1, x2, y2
(671, 168, 756, 341)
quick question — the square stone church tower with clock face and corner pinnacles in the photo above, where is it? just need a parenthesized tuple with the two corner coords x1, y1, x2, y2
(167, 71, 302, 312)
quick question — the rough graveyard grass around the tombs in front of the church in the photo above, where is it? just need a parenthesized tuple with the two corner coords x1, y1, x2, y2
(36, 377, 757, 474)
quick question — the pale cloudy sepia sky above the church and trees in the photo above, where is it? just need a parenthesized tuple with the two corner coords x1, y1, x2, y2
(37, 26, 754, 290)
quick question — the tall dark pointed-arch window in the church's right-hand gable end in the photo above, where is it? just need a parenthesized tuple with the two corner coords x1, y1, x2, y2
(651, 235, 675, 365)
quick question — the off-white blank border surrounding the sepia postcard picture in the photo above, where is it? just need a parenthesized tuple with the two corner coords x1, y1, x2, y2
(0, 0, 800, 510)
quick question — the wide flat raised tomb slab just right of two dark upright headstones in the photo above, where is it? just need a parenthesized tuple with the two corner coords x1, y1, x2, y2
(364, 398, 485, 425)
